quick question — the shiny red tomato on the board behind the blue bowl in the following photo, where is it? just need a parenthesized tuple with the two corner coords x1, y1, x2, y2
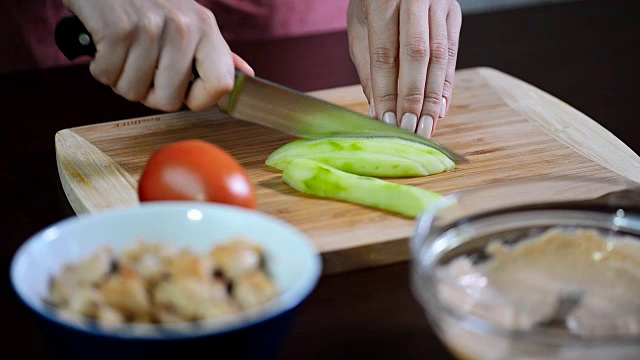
(138, 140, 256, 209)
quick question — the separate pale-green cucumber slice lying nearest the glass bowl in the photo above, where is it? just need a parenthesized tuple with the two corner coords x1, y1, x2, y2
(282, 159, 442, 218)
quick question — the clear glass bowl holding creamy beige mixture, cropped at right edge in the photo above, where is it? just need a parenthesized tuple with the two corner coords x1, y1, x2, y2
(409, 177, 640, 360)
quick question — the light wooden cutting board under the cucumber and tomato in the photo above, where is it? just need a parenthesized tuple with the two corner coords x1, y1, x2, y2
(55, 68, 640, 273)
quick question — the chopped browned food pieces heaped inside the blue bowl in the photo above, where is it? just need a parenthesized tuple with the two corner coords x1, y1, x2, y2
(45, 239, 277, 326)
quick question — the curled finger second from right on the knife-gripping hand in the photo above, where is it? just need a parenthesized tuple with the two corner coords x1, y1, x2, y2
(143, 16, 198, 111)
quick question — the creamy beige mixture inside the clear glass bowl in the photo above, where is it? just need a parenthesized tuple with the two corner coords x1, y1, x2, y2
(436, 228, 640, 337)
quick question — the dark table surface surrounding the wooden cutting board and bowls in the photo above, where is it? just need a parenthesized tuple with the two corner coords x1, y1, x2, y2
(0, 0, 640, 359)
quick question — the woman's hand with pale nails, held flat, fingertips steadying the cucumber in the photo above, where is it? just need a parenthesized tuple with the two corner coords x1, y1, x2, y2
(347, 0, 462, 138)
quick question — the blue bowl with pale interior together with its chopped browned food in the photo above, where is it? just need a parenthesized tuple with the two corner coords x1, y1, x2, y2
(11, 201, 321, 358)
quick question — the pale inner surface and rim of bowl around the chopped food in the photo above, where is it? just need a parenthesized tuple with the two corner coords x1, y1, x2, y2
(11, 202, 321, 338)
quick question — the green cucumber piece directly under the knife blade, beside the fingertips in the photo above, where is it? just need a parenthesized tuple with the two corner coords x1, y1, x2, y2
(265, 137, 455, 178)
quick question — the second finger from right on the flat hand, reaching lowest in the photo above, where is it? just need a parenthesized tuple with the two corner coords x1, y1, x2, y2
(416, 1, 449, 138)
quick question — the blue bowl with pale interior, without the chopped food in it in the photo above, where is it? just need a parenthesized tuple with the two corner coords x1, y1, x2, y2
(11, 201, 322, 359)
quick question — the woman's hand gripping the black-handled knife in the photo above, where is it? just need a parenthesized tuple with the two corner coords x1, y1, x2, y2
(63, 0, 253, 111)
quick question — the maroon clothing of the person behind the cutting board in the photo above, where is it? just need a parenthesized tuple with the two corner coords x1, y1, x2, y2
(0, 0, 349, 73)
